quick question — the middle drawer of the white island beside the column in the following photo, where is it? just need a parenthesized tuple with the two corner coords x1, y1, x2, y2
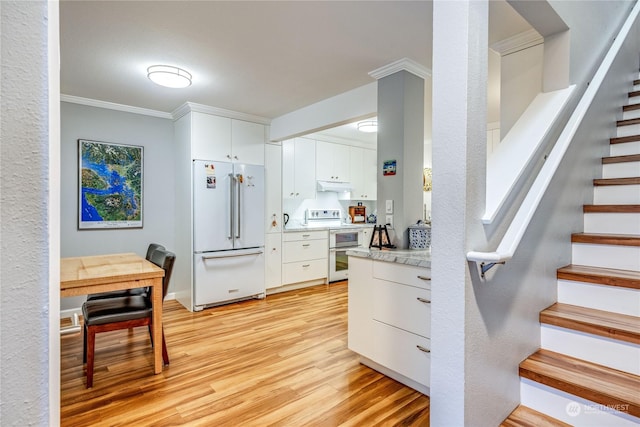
(373, 279, 431, 338)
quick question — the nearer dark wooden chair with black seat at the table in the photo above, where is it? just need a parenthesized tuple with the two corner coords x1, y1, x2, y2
(82, 249, 176, 388)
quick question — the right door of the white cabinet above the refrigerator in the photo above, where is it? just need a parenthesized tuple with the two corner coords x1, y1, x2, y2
(231, 120, 265, 165)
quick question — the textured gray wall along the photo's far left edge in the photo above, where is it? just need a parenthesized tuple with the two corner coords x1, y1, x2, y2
(0, 1, 51, 426)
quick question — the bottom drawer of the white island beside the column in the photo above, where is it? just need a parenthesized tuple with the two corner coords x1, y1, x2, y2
(371, 321, 431, 387)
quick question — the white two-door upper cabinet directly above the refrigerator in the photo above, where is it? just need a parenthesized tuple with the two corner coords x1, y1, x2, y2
(190, 111, 265, 165)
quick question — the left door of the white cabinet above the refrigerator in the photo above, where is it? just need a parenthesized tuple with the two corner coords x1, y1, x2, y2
(189, 111, 231, 162)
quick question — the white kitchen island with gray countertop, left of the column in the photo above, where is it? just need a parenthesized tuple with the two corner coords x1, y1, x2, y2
(347, 248, 431, 395)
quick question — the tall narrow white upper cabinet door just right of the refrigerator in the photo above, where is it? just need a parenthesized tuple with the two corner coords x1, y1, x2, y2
(264, 144, 282, 233)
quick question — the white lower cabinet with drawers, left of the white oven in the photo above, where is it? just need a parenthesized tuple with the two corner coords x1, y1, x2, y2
(282, 230, 329, 285)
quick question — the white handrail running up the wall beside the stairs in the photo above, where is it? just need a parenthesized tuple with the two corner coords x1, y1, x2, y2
(467, 2, 640, 278)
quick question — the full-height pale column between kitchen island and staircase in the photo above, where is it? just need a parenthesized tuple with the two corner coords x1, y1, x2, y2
(431, 0, 491, 426)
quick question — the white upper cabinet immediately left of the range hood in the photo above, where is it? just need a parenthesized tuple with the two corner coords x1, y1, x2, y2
(282, 138, 316, 199)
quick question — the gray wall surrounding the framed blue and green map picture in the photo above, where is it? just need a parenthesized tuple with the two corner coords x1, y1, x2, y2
(60, 102, 175, 310)
